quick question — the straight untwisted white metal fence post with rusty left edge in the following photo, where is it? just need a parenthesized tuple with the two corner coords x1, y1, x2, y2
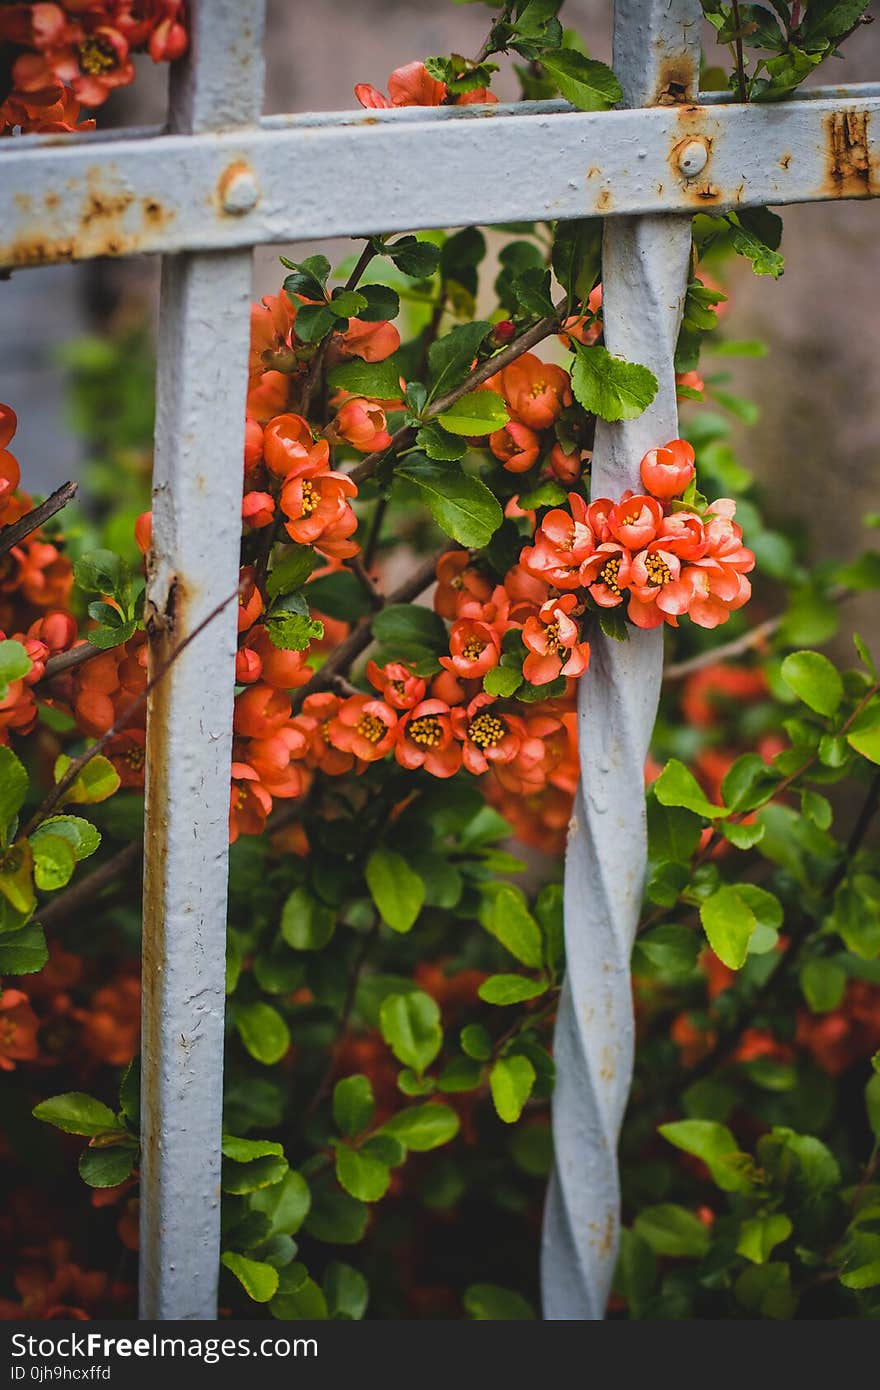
(140, 0, 264, 1318)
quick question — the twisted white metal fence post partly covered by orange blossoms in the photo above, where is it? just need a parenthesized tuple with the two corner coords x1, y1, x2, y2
(542, 0, 701, 1319)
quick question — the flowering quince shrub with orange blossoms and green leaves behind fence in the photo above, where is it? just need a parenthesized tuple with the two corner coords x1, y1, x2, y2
(0, 0, 880, 1319)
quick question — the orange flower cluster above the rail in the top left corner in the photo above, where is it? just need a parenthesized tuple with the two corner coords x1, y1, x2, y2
(0, 0, 188, 135)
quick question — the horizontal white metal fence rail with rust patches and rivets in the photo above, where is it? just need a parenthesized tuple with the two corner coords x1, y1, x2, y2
(0, 88, 880, 267)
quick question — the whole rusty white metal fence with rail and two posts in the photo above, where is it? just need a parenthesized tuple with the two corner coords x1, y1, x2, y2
(0, 0, 880, 1318)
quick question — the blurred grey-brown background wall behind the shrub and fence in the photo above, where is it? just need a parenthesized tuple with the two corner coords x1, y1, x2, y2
(0, 0, 880, 586)
